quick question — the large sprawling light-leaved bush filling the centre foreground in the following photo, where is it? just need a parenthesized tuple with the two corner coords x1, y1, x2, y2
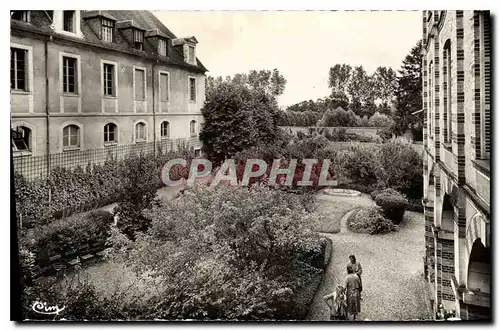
(105, 186, 324, 320)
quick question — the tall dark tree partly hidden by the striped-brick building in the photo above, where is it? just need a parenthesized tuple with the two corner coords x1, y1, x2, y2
(394, 40, 422, 134)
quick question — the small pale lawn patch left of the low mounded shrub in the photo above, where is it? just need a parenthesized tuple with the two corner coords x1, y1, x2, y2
(312, 191, 374, 233)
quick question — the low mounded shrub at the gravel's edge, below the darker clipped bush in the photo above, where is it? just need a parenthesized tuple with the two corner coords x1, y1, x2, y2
(348, 206, 396, 234)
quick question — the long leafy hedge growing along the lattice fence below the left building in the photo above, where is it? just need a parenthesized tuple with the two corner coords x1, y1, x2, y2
(14, 149, 196, 228)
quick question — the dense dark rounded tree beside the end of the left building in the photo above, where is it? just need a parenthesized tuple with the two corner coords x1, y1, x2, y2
(200, 69, 286, 161)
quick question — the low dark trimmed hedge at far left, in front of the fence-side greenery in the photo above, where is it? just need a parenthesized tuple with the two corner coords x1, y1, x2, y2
(20, 210, 114, 275)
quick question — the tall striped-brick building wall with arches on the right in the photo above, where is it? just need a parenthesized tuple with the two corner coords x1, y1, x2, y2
(422, 11, 491, 319)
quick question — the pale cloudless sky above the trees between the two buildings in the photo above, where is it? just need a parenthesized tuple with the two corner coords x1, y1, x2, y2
(154, 11, 422, 106)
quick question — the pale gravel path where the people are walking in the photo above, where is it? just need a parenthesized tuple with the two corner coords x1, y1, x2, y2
(307, 196, 428, 321)
